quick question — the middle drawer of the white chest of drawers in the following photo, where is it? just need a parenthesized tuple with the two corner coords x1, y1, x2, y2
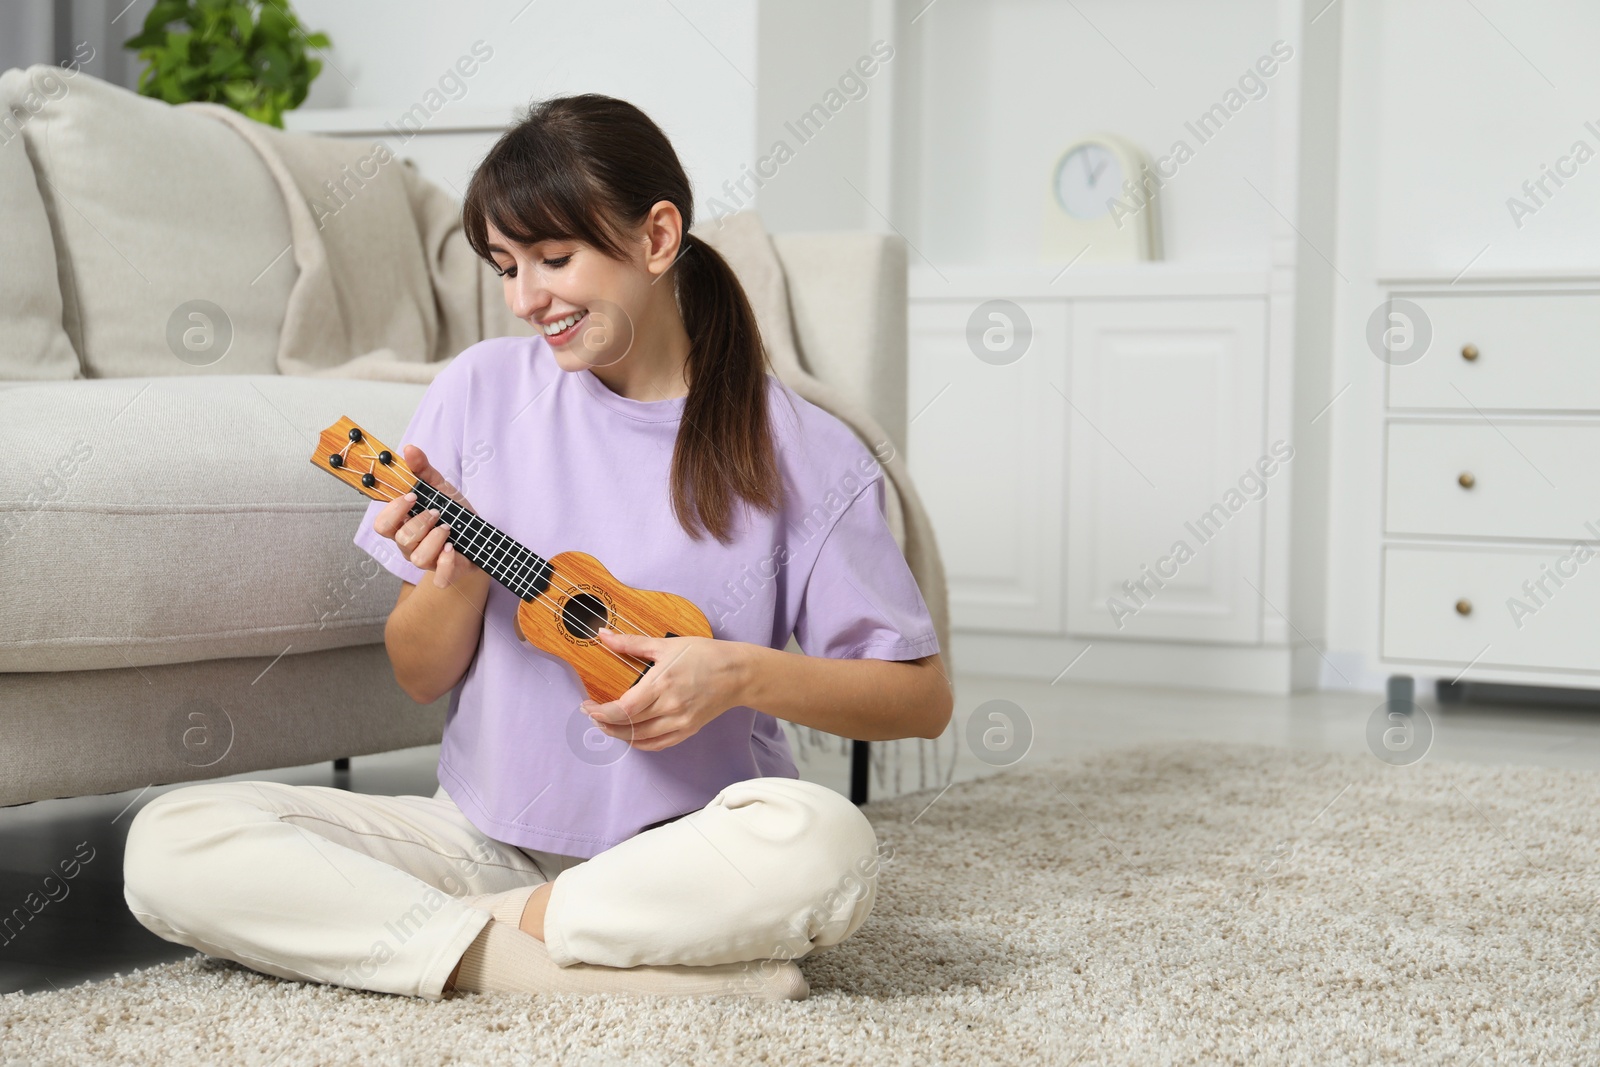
(1384, 418, 1600, 541)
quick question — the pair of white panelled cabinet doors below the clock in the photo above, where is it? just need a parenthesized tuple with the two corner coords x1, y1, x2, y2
(909, 283, 1283, 655)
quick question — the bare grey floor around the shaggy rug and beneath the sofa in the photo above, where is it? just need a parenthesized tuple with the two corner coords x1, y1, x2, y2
(0, 675, 1600, 992)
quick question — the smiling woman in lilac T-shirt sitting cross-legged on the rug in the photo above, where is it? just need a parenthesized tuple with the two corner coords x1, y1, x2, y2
(125, 94, 952, 1000)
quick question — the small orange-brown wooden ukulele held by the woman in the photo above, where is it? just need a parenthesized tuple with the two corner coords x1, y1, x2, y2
(310, 418, 712, 702)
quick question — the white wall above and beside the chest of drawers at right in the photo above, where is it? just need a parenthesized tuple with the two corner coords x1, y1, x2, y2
(1323, 0, 1600, 689)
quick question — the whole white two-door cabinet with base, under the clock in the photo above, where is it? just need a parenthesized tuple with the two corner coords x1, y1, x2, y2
(907, 264, 1333, 693)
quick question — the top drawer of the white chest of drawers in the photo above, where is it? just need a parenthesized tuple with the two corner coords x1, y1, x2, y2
(1389, 293, 1600, 411)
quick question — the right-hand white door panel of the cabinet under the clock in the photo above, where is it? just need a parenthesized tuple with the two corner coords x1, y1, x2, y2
(1062, 299, 1267, 643)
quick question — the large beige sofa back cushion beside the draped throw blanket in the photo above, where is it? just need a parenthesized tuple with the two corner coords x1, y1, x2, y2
(0, 66, 296, 378)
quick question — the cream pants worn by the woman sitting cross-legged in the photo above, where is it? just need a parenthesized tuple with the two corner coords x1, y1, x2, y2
(123, 777, 878, 998)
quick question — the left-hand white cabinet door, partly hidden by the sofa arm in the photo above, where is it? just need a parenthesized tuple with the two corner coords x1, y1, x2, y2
(907, 301, 1067, 633)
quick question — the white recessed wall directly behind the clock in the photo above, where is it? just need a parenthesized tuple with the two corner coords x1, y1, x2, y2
(917, 0, 1277, 269)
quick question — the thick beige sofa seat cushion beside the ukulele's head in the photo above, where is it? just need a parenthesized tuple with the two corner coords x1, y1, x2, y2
(0, 374, 424, 672)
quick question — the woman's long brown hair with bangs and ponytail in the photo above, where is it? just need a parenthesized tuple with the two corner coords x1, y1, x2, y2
(461, 93, 782, 542)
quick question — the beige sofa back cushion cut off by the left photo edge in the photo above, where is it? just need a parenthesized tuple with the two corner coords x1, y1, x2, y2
(0, 67, 82, 379)
